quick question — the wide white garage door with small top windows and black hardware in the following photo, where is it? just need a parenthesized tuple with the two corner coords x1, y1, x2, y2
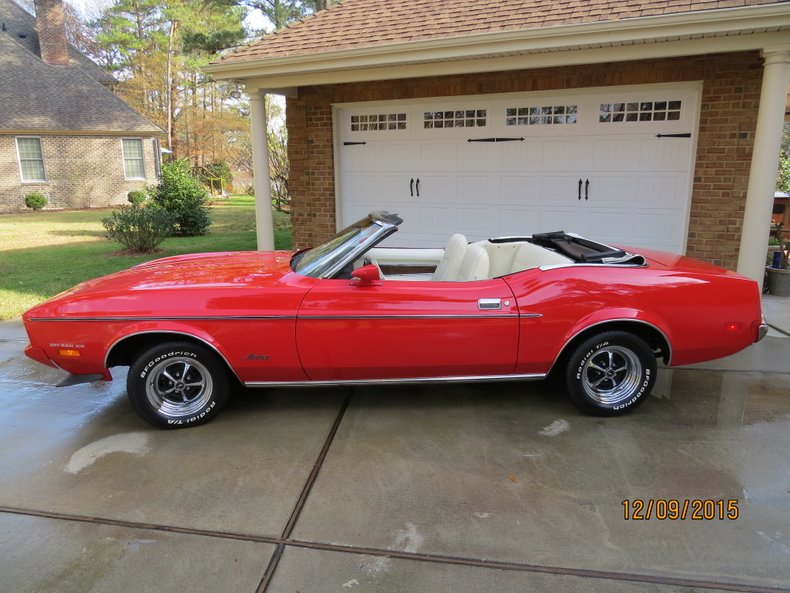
(335, 85, 700, 253)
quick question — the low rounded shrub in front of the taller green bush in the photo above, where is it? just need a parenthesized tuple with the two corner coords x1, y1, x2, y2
(101, 204, 173, 253)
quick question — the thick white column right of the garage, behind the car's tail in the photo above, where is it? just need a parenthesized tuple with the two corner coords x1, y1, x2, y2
(738, 47, 790, 287)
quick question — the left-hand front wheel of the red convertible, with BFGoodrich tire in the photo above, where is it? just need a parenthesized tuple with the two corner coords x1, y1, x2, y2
(126, 342, 230, 428)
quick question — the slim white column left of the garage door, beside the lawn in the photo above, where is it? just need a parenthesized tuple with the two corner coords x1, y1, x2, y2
(250, 92, 274, 251)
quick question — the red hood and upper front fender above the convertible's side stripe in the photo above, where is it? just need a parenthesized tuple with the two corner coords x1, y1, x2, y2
(24, 251, 314, 319)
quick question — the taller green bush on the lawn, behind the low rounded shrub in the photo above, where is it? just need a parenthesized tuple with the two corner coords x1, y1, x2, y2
(151, 159, 211, 236)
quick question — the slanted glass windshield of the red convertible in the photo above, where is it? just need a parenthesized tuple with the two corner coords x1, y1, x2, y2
(291, 217, 383, 278)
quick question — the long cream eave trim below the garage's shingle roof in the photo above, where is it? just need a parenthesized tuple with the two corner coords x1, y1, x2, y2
(204, 3, 790, 88)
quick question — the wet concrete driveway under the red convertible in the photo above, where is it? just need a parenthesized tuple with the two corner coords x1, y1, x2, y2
(0, 300, 790, 593)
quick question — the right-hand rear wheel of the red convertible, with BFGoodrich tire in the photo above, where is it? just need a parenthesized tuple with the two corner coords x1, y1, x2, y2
(565, 331, 656, 416)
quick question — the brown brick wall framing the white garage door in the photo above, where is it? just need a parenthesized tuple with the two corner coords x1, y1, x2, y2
(287, 52, 763, 269)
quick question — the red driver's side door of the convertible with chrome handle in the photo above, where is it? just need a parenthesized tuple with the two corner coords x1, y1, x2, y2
(296, 278, 519, 381)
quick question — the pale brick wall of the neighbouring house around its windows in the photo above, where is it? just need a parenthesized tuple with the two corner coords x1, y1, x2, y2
(0, 134, 156, 212)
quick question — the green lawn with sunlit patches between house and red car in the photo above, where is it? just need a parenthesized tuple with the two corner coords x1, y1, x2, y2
(0, 196, 291, 319)
